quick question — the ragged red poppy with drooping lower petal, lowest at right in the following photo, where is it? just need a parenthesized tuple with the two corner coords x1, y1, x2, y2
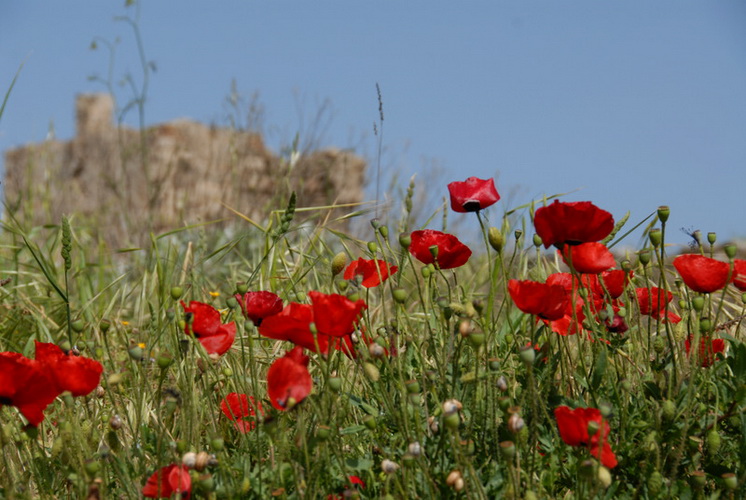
(554, 406, 617, 469)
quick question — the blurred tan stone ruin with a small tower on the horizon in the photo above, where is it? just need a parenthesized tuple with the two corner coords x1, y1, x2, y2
(4, 94, 366, 248)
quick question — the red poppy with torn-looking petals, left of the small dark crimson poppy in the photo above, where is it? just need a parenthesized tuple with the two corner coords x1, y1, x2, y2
(181, 300, 236, 355)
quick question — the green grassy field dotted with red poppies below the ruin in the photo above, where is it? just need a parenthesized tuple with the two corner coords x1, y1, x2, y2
(0, 169, 746, 499)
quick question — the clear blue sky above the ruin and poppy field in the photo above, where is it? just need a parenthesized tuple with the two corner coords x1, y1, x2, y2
(0, 0, 746, 248)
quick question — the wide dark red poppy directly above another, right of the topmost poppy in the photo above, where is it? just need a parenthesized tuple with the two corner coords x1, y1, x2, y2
(534, 200, 614, 248)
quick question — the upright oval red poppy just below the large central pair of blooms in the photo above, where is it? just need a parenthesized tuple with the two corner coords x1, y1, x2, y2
(267, 346, 313, 411)
